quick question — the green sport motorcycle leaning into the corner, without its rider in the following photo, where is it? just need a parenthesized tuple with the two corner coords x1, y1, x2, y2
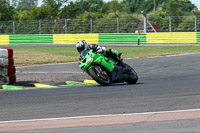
(80, 49, 138, 86)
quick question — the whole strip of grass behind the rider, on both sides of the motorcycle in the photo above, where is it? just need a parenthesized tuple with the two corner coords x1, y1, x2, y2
(1, 46, 200, 66)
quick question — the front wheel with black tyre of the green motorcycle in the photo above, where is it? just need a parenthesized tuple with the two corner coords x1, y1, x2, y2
(89, 66, 111, 86)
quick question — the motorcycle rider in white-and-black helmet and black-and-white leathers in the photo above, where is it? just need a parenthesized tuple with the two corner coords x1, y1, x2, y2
(76, 40, 131, 71)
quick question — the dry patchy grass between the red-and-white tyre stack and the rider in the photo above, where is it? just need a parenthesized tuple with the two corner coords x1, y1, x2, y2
(13, 47, 79, 66)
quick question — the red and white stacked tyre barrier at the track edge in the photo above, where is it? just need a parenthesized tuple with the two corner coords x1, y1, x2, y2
(0, 48, 16, 84)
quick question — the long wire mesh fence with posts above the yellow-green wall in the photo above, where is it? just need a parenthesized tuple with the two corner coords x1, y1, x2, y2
(0, 13, 200, 35)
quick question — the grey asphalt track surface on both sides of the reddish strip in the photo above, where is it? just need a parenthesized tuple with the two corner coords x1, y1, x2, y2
(0, 54, 200, 133)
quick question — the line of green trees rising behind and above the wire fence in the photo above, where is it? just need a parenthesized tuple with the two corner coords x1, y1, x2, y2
(0, 0, 200, 32)
